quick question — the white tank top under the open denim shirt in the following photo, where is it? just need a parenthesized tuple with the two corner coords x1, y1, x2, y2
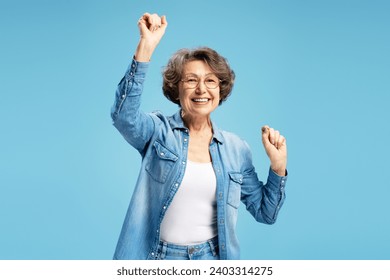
(160, 160, 217, 245)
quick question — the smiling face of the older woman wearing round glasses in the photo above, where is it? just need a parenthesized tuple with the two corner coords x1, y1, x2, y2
(179, 60, 220, 118)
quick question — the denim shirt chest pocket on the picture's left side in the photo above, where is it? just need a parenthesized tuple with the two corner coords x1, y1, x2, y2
(145, 141, 179, 183)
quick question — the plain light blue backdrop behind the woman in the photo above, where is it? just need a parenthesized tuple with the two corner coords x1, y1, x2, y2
(0, 0, 390, 259)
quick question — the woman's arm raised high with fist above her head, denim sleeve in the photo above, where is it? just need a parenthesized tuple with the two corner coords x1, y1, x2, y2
(111, 13, 167, 154)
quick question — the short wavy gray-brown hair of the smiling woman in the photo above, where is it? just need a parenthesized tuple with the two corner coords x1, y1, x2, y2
(162, 47, 235, 106)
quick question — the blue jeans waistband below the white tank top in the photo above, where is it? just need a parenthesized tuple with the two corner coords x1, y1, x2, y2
(157, 237, 219, 260)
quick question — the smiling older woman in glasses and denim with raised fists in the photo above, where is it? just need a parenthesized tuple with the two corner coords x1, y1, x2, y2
(111, 13, 287, 260)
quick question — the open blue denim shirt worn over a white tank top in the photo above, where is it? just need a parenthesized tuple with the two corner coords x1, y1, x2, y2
(111, 60, 287, 260)
